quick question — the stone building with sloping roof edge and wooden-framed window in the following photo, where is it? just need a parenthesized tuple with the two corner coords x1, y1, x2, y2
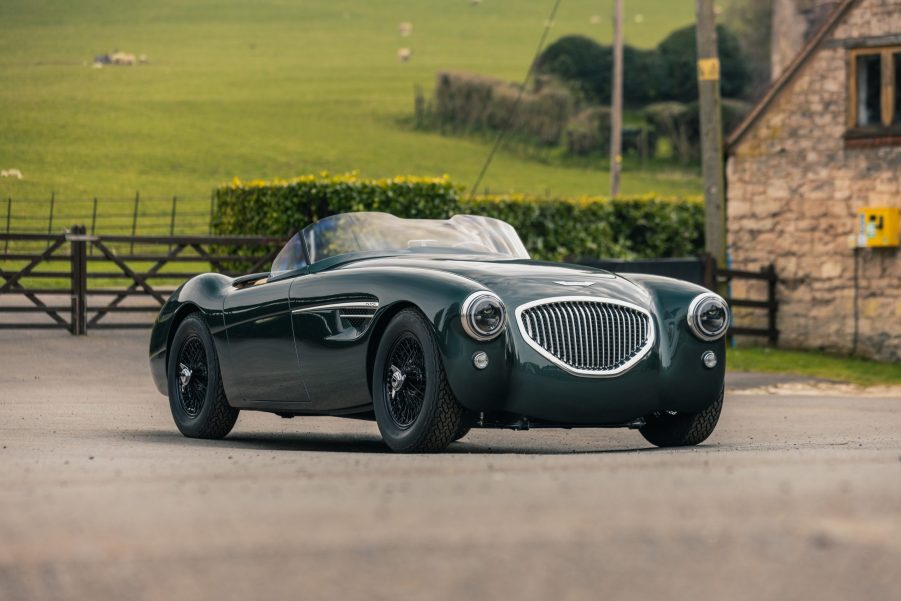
(727, 0, 901, 360)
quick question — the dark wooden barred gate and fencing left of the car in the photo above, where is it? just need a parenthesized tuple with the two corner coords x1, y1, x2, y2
(0, 226, 284, 335)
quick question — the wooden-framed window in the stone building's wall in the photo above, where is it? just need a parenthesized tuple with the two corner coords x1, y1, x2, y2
(848, 47, 901, 136)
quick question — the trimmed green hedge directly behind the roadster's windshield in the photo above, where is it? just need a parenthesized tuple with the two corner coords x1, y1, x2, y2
(213, 174, 704, 261)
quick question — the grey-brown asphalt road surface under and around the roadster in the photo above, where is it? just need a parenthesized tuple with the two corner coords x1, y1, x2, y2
(0, 331, 901, 601)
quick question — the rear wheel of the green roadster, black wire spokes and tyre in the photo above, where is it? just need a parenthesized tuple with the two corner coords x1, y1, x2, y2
(167, 315, 240, 438)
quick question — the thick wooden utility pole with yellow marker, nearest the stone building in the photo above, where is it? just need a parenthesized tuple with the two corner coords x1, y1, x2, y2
(695, 0, 726, 266)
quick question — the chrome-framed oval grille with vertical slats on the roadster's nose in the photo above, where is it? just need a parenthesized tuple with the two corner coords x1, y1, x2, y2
(516, 296, 655, 378)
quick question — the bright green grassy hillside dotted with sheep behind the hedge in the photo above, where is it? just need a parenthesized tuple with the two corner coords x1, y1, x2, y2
(0, 0, 700, 210)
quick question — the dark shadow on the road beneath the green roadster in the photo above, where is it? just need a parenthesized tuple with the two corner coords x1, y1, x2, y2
(121, 430, 684, 455)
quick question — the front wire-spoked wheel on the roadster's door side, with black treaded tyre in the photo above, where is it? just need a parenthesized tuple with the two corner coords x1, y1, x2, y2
(372, 309, 464, 453)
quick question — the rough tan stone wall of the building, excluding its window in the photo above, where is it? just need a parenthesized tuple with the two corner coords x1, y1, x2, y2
(727, 0, 901, 360)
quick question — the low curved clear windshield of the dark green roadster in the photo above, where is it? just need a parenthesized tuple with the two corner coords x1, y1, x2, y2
(302, 213, 529, 263)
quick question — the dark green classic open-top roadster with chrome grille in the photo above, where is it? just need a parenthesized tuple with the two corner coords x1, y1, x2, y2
(150, 213, 729, 452)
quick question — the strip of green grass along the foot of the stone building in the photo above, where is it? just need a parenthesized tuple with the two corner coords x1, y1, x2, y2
(726, 348, 901, 386)
